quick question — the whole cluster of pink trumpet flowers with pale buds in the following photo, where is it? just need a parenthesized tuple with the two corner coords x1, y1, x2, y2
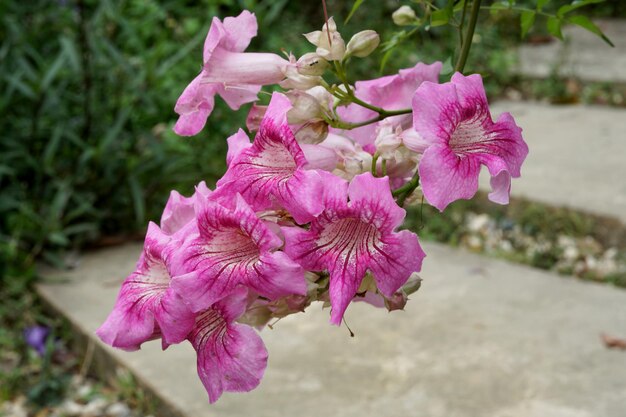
(97, 11, 528, 402)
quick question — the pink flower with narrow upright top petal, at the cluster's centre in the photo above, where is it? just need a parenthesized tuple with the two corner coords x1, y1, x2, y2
(217, 93, 322, 223)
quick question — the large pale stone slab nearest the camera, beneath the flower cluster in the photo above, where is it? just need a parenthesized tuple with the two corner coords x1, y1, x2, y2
(38, 243, 626, 417)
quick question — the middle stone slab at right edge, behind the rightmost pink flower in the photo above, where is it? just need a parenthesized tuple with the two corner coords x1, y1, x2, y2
(488, 101, 626, 223)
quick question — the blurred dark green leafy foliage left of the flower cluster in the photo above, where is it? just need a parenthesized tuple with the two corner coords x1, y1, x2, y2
(0, 0, 246, 272)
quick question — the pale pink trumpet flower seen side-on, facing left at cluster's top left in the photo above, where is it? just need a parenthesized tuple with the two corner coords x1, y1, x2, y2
(174, 10, 289, 136)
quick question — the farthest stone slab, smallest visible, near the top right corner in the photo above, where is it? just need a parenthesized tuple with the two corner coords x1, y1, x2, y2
(518, 19, 626, 83)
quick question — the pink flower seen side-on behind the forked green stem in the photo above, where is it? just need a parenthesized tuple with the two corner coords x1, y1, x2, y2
(337, 62, 442, 145)
